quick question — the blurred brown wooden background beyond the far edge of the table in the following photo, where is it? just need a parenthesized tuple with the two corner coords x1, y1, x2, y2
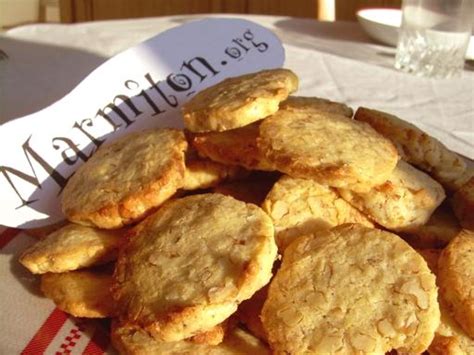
(0, 0, 401, 30)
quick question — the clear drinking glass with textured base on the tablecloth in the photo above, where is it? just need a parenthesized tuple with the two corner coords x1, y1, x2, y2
(395, 0, 474, 78)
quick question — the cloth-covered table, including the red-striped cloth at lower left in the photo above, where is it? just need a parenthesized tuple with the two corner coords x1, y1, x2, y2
(0, 15, 474, 354)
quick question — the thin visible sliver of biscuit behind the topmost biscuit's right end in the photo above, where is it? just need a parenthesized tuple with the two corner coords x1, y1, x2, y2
(280, 96, 354, 118)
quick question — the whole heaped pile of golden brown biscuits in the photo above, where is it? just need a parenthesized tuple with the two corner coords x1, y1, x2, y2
(20, 69, 474, 354)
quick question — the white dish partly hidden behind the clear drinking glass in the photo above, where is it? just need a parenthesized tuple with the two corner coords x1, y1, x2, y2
(357, 9, 474, 60)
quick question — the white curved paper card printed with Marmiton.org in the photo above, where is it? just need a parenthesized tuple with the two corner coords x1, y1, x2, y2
(0, 18, 285, 228)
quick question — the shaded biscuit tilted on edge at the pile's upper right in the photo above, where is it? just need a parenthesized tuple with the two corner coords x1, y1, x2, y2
(354, 107, 473, 191)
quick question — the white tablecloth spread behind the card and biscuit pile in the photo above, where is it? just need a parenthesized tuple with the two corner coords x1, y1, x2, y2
(0, 15, 474, 159)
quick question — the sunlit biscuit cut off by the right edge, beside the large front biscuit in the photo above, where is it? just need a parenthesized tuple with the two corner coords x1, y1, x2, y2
(438, 230, 474, 338)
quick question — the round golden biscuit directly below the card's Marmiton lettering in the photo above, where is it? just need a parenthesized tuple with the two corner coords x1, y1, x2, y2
(61, 128, 187, 229)
